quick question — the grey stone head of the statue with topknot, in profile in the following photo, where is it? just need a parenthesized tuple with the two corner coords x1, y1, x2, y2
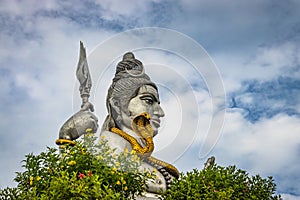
(102, 52, 164, 135)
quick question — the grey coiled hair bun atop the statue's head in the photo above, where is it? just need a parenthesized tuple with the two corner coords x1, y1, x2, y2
(116, 52, 144, 75)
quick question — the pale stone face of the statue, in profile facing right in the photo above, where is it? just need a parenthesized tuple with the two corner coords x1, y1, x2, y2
(122, 85, 165, 136)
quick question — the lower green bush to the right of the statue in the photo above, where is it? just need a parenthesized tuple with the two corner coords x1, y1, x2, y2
(162, 165, 281, 200)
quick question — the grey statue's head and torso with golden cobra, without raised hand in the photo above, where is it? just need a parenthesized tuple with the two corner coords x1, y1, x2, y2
(100, 52, 179, 196)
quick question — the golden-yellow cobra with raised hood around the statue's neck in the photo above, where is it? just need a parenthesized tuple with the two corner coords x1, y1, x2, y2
(110, 113, 179, 184)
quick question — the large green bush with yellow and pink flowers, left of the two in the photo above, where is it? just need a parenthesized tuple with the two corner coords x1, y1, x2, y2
(0, 135, 153, 199)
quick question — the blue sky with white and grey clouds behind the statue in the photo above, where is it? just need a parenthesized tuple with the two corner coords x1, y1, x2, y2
(0, 0, 300, 199)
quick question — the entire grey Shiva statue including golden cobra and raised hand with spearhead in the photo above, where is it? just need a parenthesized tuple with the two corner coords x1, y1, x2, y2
(56, 43, 179, 199)
